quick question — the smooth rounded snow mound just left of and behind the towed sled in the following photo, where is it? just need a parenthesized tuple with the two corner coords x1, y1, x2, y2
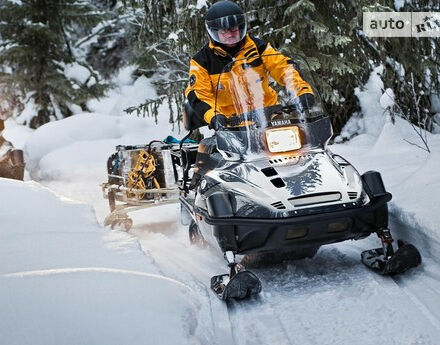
(24, 113, 179, 181)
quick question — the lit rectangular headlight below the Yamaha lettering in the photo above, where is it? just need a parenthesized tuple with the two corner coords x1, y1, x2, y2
(266, 126, 301, 153)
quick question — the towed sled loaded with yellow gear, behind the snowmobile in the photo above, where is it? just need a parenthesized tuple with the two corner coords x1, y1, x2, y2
(102, 140, 197, 231)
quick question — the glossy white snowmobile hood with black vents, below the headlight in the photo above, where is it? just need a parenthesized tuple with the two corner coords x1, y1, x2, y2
(205, 151, 364, 217)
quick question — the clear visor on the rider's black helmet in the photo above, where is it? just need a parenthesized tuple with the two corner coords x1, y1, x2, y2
(206, 14, 246, 45)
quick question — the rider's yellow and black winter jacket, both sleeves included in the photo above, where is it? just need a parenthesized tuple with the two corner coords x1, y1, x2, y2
(185, 35, 313, 124)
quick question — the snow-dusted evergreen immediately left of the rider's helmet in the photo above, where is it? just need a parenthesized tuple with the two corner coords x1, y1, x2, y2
(121, 0, 209, 125)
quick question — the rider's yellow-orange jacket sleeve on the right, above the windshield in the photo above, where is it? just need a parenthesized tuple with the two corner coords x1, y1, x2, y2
(261, 44, 313, 96)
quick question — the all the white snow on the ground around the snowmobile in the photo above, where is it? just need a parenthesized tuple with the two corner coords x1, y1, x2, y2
(0, 63, 440, 345)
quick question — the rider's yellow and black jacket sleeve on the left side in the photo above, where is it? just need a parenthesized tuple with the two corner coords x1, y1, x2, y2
(185, 59, 214, 124)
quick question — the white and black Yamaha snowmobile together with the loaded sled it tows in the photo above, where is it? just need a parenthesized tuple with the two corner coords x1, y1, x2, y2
(104, 56, 421, 300)
